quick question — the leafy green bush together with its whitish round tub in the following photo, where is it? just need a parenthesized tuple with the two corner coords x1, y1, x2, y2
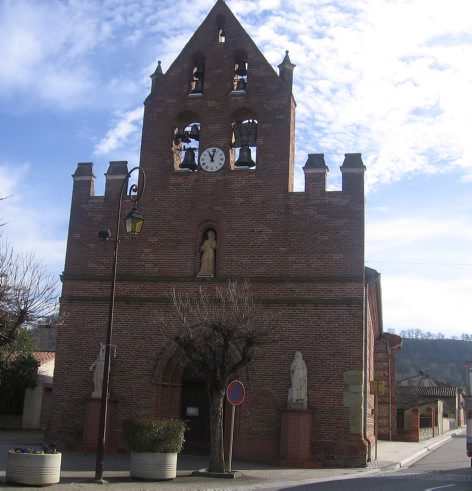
(122, 418, 186, 481)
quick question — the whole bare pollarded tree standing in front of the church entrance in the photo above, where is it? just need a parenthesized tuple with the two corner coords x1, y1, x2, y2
(166, 281, 275, 472)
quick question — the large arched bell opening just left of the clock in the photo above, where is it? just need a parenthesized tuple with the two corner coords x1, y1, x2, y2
(172, 116, 201, 172)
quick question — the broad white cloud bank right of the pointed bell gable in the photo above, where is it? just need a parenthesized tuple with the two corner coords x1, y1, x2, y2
(230, 0, 472, 188)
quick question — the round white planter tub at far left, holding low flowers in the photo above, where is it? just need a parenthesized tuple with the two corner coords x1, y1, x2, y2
(5, 450, 62, 486)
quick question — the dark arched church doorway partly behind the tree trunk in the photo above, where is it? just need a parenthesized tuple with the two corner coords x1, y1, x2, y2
(181, 364, 210, 455)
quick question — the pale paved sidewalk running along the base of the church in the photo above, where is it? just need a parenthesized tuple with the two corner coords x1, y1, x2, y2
(0, 430, 463, 491)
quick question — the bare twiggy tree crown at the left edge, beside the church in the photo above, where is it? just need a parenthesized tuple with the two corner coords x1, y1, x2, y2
(0, 244, 58, 348)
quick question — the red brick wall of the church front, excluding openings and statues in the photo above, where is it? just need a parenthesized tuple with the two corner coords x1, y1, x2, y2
(51, 2, 372, 465)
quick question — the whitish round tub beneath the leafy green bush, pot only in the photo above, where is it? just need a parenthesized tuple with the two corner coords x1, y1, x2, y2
(129, 452, 177, 481)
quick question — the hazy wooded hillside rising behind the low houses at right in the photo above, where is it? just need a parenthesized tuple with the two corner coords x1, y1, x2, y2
(397, 339, 472, 388)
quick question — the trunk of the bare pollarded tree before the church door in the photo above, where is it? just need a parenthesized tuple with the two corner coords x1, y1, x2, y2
(208, 390, 225, 472)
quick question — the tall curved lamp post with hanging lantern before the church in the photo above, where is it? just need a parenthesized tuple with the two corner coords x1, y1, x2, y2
(95, 167, 146, 482)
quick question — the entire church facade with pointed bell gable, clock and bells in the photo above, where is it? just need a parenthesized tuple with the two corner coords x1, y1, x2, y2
(49, 0, 393, 466)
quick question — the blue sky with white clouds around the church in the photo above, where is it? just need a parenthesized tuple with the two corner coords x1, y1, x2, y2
(0, 0, 472, 337)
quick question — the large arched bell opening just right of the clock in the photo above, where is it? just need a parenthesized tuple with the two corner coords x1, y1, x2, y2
(230, 118, 257, 169)
